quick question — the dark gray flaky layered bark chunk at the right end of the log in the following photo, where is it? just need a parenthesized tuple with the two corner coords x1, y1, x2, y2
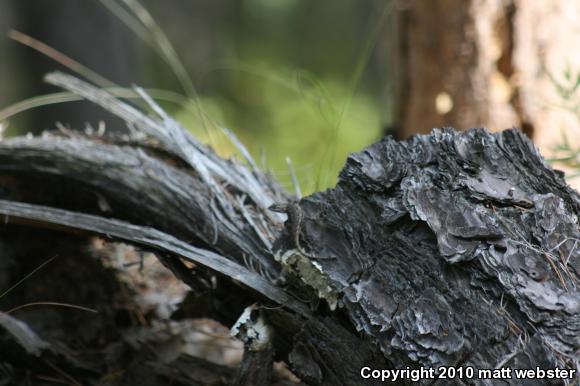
(294, 130, 580, 383)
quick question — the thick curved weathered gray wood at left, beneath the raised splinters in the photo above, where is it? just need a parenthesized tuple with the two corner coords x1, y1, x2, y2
(0, 137, 279, 277)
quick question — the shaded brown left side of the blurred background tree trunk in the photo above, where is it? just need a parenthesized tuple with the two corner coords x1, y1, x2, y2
(394, 0, 489, 138)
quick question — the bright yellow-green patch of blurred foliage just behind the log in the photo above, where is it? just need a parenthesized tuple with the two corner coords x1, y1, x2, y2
(175, 69, 381, 192)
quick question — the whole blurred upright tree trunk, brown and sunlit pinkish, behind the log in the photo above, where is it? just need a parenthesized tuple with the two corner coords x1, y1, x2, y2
(394, 0, 580, 156)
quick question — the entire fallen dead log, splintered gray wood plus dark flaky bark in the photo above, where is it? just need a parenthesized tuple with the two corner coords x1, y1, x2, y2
(0, 74, 580, 385)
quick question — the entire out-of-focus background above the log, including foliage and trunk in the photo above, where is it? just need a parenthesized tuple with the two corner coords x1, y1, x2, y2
(0, 0, 580, 194)
